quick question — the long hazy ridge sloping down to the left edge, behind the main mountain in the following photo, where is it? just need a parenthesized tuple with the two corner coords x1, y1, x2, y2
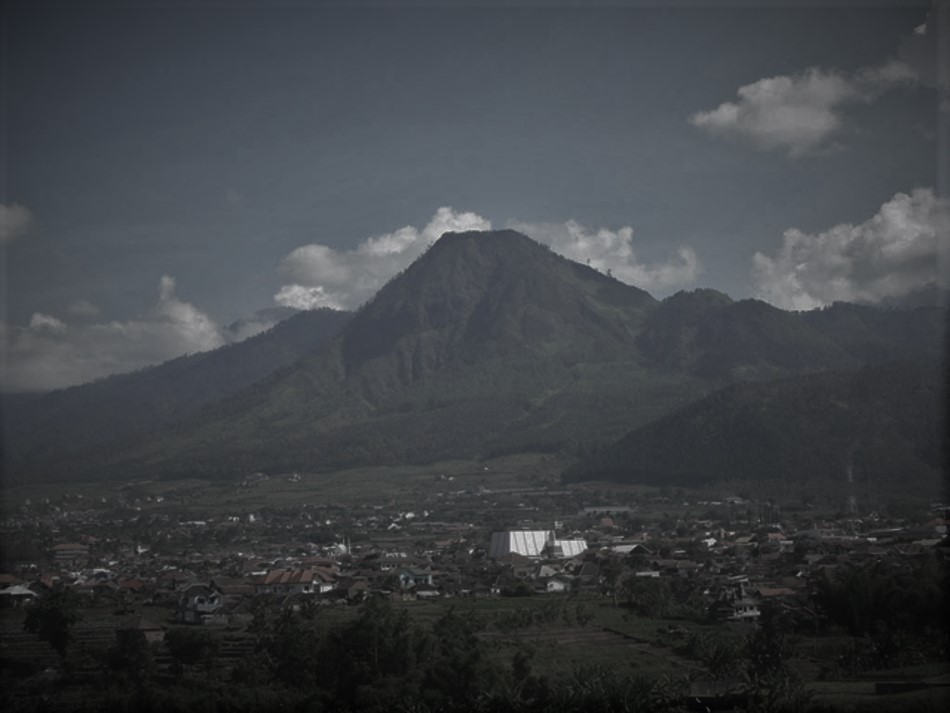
(2, 310, 350, 470)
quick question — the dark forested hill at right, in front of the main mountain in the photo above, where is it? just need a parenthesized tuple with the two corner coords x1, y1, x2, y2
(565, 364, 947, 492)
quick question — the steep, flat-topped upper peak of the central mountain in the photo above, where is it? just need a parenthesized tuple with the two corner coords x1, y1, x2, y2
(344, 230, 656, 366)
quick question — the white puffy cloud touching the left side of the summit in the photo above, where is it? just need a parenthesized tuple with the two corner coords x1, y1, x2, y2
(274, 207, 491, 309)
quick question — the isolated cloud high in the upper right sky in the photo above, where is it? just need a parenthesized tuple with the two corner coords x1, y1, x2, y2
(689, 60, 916, 158)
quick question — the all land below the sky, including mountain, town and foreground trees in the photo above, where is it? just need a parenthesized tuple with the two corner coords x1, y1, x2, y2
(0, 231, 950, 713)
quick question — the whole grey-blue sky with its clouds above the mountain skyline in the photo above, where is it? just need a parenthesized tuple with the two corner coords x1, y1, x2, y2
(0, 0, 950, 392)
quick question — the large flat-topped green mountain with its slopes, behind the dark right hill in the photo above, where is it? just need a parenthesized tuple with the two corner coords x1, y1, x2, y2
(3, 231, 946, 486)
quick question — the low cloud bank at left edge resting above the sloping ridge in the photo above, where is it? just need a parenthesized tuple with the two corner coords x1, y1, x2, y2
(0, 275, 256, 391)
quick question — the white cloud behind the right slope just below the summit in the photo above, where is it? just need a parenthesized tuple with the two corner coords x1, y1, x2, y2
(509, 220, 702, 292)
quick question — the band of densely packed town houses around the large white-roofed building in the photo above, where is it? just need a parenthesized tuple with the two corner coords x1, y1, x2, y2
(0, 472, 947, 640)
